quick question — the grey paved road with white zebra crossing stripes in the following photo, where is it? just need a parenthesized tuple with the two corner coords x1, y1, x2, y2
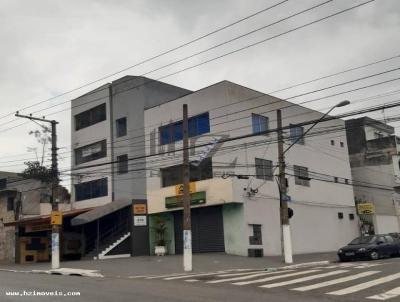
(0, 258, 400, 302)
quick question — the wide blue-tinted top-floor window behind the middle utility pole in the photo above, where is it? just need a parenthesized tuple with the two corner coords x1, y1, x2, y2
(159, 112, 210, 145)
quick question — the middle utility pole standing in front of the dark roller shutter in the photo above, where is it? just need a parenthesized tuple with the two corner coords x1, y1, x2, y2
(182, 104, 192, 272)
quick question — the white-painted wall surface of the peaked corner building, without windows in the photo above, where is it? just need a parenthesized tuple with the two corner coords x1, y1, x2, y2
(145, 81, 358, 255)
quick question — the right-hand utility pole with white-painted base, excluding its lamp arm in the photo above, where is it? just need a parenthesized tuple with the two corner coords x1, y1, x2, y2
(276, 109, 293, 263)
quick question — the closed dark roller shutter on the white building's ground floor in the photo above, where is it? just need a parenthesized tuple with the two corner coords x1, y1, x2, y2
(174, 206, 225, 254)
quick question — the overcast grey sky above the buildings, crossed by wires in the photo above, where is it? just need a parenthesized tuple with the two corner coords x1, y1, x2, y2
(0, 0, 400, 188)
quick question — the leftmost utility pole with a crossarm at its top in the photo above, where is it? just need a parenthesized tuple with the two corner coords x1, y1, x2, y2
(15, 111, 60, 269)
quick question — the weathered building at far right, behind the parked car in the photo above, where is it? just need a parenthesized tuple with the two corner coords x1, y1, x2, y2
(346, 117, 400, 234)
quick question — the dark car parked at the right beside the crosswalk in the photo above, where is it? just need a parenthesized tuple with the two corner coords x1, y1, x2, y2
(338, 235, 400, 261)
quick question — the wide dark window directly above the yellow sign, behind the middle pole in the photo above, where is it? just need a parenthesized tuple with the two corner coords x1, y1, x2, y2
(161, 158, 213, 187)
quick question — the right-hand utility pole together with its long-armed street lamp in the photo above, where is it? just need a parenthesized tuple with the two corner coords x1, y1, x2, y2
(277, 100, 350, 263)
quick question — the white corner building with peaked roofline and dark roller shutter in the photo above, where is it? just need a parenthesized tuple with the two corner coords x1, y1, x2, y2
(145, 81, 359, 256)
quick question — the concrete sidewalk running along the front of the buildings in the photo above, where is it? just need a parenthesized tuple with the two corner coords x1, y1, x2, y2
(0, 252, 337, 277)
